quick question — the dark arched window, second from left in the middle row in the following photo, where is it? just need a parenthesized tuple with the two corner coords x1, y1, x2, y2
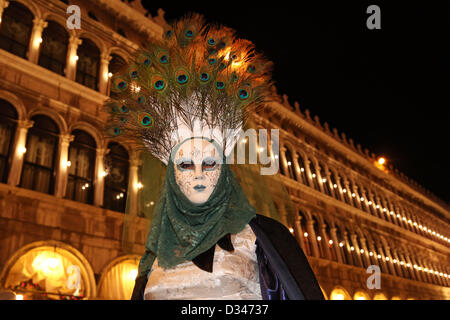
(20, 115, 59, 194)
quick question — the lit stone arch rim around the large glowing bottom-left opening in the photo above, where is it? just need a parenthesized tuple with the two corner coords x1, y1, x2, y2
(0, 240, 97, 297)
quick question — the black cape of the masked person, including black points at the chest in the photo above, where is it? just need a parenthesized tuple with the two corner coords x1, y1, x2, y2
(131, 215, 325, 300)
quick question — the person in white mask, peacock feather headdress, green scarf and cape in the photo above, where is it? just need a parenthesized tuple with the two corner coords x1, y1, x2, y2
(106, 14, 323, 300)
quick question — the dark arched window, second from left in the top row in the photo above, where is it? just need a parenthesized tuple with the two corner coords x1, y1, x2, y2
(38, 21, 69, 75)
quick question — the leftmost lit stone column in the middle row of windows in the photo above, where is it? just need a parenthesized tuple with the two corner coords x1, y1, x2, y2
(8, 120, 34, 187)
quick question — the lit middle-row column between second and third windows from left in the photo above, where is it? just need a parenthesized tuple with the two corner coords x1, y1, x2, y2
(55, 134, 75, 198)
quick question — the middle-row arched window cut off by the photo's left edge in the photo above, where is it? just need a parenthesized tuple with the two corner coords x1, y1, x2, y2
(0, 99, 18, 183)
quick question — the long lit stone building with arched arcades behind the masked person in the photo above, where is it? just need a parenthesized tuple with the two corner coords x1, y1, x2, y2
(0, 0, 450, 299)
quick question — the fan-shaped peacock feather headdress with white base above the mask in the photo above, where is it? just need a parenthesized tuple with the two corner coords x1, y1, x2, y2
(106, 14, 272, 164)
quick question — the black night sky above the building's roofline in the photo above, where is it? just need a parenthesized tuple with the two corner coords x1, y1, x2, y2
(142, 0, 450, 203)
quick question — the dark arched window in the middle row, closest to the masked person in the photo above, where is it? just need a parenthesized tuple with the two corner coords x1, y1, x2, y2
(103, 142, 129, 212)
